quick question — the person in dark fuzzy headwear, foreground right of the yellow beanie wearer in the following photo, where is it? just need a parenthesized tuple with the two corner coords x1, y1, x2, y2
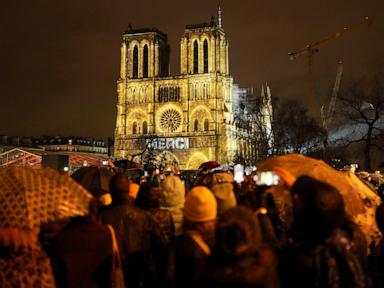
(199, 207, 279, 288)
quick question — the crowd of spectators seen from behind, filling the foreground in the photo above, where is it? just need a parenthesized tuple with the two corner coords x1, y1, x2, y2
(0, 161, 384, 288)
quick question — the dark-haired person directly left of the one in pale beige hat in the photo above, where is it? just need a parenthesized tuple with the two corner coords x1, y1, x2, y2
(135, 182, 175, 287)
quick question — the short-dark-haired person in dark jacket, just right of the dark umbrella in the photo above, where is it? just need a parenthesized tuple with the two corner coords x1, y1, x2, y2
(100, 174, 154, 287)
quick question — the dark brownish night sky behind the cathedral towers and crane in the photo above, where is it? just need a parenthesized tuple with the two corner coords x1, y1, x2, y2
(0, 0, 384, 137)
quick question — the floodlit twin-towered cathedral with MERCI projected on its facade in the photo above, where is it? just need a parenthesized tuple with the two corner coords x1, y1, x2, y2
(114, 9, 272, 169)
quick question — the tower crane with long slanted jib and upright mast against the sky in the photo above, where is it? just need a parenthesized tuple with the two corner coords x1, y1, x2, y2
(288, 17, 371, 108)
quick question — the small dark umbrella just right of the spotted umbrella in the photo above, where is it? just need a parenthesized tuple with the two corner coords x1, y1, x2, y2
(71, 166, 113, 197)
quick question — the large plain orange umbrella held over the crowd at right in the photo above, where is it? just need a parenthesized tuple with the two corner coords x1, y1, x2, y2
(257, 154, 380, 243)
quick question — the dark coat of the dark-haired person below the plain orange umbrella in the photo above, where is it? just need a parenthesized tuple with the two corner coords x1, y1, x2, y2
(280, 230, 369, 288)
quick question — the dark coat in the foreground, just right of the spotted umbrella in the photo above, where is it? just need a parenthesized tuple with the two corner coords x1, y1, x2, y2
(49, 216, 113, 288)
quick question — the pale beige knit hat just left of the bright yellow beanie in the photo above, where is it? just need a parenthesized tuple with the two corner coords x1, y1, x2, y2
(161, 176, 185, 207)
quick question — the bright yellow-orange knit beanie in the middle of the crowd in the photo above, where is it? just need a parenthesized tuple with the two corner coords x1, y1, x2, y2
(184, 186, 217, 222)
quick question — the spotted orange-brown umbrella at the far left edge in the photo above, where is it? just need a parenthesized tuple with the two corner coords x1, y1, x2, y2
(0, 167, 92, 230)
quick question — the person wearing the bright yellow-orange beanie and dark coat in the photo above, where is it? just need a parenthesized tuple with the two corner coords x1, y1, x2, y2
(170, 186, 217, 287)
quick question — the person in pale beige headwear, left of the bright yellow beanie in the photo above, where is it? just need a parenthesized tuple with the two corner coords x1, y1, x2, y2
(160, 176, 185, 236)
